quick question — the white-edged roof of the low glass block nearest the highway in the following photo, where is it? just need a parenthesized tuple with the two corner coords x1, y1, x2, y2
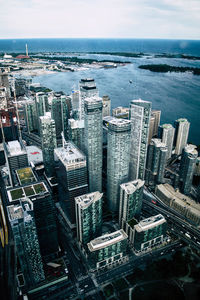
(134, 214, 166, 232)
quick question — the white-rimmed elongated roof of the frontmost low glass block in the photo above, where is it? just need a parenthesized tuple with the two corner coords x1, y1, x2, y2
(87, 229, 128, 252)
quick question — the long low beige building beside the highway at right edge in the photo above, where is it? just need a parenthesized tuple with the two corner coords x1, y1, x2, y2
(155, 184, 200, 226)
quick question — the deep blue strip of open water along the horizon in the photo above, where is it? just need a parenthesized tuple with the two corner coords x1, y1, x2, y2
(0, 39, 200, 56)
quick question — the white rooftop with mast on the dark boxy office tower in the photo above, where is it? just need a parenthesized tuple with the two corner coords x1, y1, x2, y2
(54, 142, 86, 168)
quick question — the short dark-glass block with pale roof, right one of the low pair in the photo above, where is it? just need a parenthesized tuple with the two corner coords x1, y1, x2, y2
(133, 214, 167, 252)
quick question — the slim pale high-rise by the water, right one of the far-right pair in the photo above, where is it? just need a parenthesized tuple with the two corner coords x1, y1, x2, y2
(174, 119, 190, 155)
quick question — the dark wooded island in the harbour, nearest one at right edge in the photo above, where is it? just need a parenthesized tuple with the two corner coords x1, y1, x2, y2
(138, 64, 200, 75)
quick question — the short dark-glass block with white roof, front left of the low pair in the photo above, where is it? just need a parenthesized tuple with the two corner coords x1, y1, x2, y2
(87, 229, 128, 270)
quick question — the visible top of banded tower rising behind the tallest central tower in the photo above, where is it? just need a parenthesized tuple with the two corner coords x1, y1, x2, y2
(79, 78, 99, 120)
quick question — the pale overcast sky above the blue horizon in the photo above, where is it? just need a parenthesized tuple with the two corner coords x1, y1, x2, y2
(0, 0, 200, 40)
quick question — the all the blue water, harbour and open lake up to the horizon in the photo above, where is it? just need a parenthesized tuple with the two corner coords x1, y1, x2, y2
(0, 39, 200, 145)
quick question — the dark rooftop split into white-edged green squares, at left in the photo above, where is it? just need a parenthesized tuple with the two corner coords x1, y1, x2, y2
(7, 182, 48, 202)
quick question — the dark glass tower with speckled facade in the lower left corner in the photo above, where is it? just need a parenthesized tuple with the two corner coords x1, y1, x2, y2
(7, 199, 45, 288)
